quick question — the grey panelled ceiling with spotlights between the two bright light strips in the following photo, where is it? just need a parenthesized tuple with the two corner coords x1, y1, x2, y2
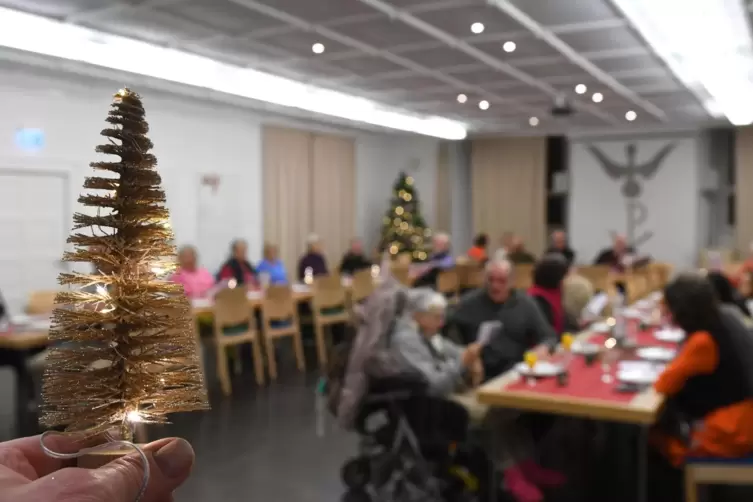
(0, 0, 740, 134)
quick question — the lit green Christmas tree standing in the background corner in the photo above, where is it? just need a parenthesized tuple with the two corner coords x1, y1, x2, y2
(380, 173, 431, 262)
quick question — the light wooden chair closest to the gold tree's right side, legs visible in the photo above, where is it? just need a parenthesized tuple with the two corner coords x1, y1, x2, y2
(214, 288, 264, 396)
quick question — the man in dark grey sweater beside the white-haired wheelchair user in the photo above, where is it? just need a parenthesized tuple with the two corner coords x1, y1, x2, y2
(445, 260, 557, 378)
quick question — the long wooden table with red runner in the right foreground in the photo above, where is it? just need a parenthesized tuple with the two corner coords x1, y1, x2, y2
(476, 294, 677, 502)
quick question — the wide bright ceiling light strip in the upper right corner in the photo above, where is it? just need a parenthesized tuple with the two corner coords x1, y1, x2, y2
(613, 0, 753, 125)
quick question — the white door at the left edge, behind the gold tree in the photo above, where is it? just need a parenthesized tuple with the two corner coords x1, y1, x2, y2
(0, 169, 70, 313)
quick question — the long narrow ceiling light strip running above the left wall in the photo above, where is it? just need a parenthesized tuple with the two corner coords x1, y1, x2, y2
(0, 8, 467, 140)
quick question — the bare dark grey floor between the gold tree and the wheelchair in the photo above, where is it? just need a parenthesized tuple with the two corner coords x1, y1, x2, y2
(0, 348, 355, 502)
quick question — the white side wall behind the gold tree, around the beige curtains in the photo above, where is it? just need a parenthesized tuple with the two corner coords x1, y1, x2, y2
(0, 63, 437, 312)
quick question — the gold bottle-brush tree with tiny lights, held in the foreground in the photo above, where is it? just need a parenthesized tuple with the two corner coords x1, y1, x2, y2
(41, 89, 209, 441)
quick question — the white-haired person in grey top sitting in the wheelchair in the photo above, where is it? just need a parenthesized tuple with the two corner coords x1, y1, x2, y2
(392, 288, 483, 397)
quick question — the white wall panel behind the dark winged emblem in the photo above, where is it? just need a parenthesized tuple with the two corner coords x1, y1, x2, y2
(569, 134, 702, 267)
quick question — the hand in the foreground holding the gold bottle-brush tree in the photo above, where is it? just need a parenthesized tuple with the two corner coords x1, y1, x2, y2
(0, 436, 194, 502)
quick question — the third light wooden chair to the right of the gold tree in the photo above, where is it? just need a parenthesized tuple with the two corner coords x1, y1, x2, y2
(311, 275, 350, 370)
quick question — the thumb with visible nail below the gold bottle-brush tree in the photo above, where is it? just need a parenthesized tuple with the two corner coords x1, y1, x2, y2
(90, 438, 194, 502)
